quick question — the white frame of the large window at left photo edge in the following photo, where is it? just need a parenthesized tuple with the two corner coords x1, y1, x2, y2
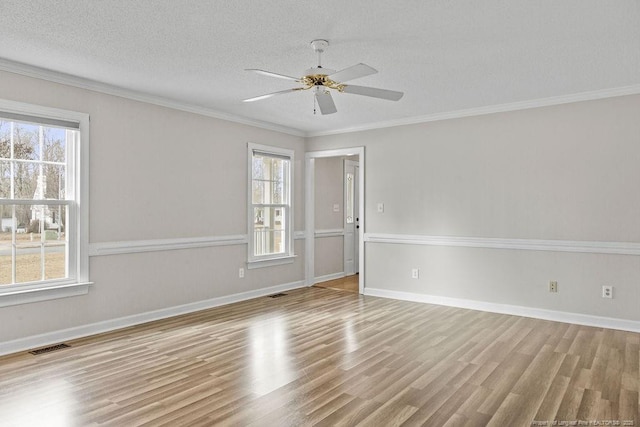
(0, 99, 92, 307)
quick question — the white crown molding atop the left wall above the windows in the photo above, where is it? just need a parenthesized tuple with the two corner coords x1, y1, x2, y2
(0, 58, 306, 137)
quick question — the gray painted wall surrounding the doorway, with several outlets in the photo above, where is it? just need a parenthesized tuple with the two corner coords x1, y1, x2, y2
(307, 96, 640, 320)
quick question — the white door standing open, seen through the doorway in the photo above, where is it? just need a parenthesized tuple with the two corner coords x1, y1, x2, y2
(344, 160, 360, 276)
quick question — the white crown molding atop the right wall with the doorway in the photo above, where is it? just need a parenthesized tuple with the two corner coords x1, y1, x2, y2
(306, 84, 640, 137)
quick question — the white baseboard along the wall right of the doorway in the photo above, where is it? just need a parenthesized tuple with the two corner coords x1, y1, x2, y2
(364, 288, 640, 332)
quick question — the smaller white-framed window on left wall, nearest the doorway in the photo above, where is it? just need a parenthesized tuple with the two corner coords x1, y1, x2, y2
(248, 144, 293, 268)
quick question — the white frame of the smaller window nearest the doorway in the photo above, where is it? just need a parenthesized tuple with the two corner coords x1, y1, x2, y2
(247, 143, 295, 269)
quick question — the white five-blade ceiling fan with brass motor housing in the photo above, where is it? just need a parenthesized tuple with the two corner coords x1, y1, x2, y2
(243, 40, 404, 115)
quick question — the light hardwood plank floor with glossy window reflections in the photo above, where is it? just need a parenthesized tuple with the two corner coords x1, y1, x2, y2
(0, 287, 640, 426)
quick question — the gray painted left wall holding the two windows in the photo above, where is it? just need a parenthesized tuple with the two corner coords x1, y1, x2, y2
(0, 72, 304, 342)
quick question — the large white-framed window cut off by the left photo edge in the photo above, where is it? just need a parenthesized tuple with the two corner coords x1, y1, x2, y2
(0, 101, 88, 306)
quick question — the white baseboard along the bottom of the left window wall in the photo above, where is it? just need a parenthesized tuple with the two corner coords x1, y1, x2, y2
(0, 280, 305, 356)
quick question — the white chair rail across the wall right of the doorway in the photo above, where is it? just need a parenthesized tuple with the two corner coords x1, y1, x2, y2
(364, 233, 640, 255)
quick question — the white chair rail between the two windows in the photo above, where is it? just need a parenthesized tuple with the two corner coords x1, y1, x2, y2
(89, 234, 247, 256)
